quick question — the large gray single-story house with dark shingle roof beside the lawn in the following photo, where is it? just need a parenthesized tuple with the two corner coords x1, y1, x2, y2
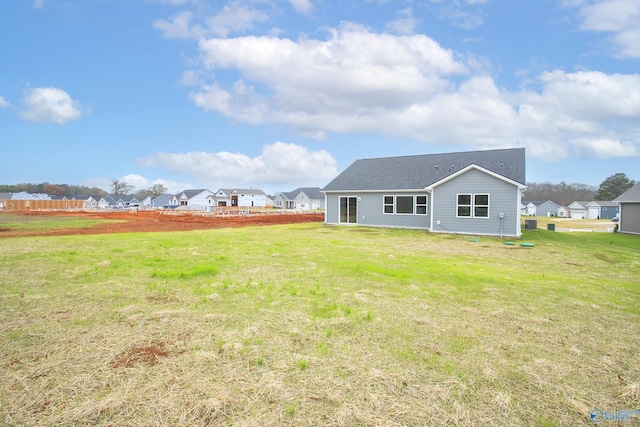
(322, 148, 526, 236)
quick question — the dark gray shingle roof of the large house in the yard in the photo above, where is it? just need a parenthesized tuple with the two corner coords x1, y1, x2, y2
(322, 148, 526, 191)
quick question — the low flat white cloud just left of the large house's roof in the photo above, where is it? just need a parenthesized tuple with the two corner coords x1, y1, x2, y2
(138, 142, 337, 190)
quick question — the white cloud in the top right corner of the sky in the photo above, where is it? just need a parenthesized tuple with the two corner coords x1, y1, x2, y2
(565, 0, 640, 58)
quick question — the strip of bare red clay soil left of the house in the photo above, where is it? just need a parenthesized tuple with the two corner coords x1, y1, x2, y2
(0, 211, 324, 238)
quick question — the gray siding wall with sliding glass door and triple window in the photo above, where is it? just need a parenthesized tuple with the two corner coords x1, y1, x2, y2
(325, 190, 431, 229)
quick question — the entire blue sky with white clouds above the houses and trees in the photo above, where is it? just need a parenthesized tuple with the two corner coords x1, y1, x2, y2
(0, 0, 640, 194)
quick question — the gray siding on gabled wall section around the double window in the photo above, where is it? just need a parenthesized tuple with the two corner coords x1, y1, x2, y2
(432, 169, 520, 236)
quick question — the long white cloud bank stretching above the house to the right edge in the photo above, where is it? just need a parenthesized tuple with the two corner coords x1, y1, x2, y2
(170, 23, 640, 160)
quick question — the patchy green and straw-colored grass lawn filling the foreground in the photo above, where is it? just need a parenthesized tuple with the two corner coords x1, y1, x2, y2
(0, 223, 640, 426)
